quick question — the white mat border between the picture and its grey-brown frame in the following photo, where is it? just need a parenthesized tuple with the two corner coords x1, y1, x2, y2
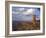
(9, 4, 43, 34)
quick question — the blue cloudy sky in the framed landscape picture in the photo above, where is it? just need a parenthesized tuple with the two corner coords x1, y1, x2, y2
(12, 7, 40, 21)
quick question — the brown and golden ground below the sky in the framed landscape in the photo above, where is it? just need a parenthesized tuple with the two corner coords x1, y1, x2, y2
(13, 22, 40, 31)
